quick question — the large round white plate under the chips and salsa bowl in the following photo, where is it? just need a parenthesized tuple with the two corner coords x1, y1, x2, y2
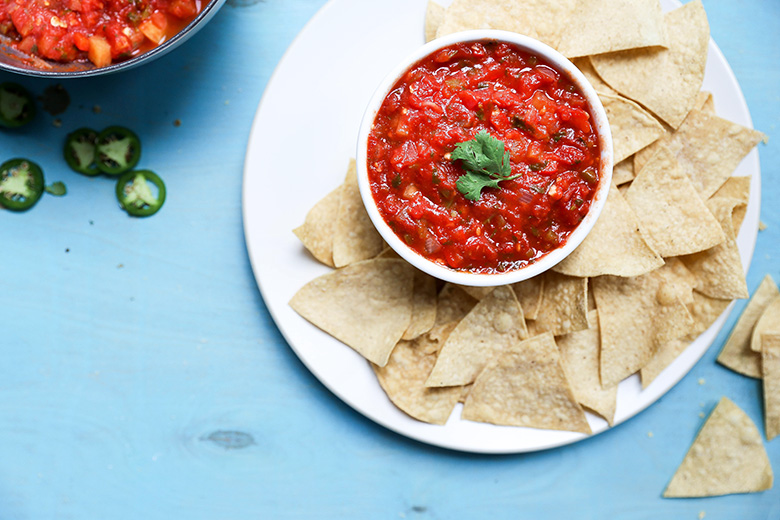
(243, 0, 760, 453)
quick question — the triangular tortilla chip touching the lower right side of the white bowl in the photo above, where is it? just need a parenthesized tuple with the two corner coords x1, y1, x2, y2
(553, 184, 664, 277)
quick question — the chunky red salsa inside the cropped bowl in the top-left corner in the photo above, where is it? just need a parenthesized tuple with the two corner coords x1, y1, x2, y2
(0, 0, 201, 67)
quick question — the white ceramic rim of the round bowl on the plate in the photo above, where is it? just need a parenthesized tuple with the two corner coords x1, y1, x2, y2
(356, 30, 613, 287)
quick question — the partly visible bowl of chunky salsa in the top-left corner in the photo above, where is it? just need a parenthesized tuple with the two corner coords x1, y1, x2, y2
(0, 0, 225, 78)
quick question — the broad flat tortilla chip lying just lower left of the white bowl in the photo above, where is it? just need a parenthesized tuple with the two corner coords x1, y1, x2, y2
(290, 259, 414, 366)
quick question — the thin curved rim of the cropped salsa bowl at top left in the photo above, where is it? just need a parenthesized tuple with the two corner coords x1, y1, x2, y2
(0, 0, 226, 79)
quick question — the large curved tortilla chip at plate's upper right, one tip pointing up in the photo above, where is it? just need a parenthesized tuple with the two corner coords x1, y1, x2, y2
(591, 0, 710, 128)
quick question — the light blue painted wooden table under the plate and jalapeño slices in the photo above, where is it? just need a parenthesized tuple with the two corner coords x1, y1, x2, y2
(0, 0, 780, 520)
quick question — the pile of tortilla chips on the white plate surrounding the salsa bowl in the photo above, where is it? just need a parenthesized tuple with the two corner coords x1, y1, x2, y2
(290, 0, 764, 434)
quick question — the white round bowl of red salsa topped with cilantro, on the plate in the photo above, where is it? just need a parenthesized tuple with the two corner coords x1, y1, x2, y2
(356, 30, 613, 286)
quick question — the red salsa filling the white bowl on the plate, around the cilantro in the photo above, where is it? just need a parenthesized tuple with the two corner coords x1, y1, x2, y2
(367, 41, 600, 273)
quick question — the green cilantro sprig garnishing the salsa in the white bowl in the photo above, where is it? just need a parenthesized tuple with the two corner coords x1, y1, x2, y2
(450, 130, 520, 200)
